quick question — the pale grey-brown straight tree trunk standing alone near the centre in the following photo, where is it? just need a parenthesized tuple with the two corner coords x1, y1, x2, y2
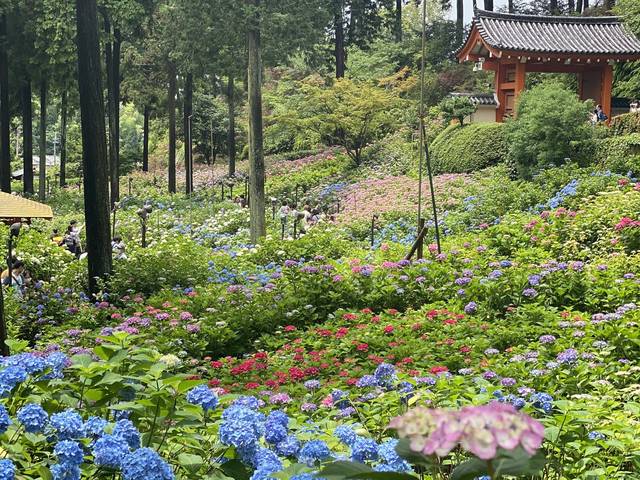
(247, 0, 266, 244)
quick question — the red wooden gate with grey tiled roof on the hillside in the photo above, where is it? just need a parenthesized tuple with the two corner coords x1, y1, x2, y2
(456, 10, 640, 122)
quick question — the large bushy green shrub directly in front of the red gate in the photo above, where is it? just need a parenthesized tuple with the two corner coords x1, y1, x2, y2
(506, 83, 592, 178)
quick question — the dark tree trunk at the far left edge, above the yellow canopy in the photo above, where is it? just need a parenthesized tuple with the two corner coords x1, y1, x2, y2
(0, 13, 11, 193)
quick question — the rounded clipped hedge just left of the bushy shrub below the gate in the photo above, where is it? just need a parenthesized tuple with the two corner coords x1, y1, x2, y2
(430, 123, 509, 173)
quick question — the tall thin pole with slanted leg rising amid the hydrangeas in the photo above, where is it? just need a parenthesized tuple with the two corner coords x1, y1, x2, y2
(418, 0, 442, 253)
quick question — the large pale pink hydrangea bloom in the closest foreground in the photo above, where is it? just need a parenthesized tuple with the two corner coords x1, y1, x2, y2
(390, 402, 544, 460)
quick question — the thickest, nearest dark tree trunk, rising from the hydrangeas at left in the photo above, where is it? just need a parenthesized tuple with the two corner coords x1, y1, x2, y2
(76, 0, 111, 293)
